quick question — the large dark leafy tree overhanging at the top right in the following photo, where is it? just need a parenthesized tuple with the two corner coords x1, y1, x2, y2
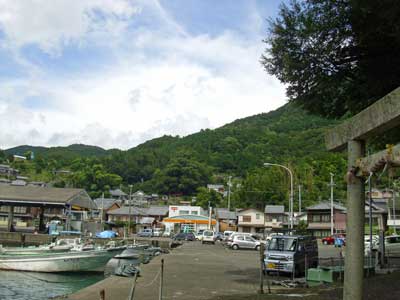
(261, 0, 400, 117)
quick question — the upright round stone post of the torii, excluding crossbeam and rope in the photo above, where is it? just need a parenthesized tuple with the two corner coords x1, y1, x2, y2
(343, 141, 365, 300)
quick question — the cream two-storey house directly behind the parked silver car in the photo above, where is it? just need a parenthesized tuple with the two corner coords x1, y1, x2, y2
(237, 208, 265, 233)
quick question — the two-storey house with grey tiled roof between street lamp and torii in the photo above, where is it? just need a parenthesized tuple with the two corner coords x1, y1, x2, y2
(306, 201, 346, 237)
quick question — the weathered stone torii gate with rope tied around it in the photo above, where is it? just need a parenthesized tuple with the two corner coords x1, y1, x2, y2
(325, 88, 400, 300)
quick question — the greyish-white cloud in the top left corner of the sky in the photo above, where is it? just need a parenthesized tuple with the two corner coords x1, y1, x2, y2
(0, 0, 138, 54)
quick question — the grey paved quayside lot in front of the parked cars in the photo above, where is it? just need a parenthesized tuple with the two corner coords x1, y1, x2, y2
(68, 242, 339, 300)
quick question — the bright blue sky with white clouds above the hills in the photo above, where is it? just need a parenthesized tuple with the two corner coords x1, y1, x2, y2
(0, 0, 286, 149)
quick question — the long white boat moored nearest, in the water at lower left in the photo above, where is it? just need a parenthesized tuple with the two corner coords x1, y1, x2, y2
(0, 247, 125, 273)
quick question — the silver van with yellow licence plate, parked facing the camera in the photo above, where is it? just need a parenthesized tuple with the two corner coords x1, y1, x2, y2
(264, 235, 318, 276)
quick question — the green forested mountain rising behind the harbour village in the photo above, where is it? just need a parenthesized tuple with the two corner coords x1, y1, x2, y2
(0, 104, 345, 207)
